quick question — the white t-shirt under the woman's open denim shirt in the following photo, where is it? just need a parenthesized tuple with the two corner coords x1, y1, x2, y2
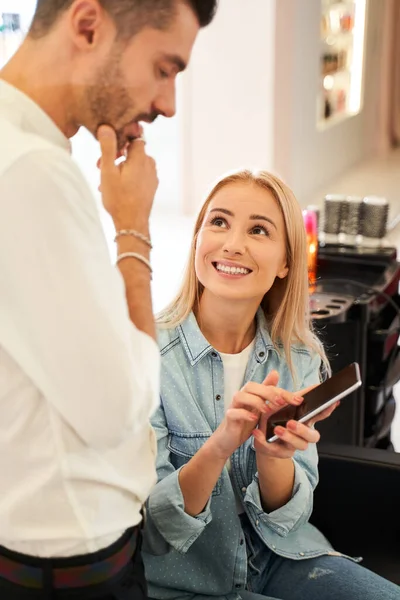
(219, 340, 255, 514)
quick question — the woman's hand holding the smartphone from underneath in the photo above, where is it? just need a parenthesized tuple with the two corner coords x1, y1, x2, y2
(253, 371, 340, 458)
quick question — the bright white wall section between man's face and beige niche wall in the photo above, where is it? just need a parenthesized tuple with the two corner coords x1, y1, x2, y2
(182, 0, 280, 213)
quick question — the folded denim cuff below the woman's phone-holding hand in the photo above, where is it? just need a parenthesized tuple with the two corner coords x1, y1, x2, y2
(244, 460, 313, 537)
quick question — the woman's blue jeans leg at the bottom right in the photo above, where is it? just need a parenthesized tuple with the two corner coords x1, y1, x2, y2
(240, 553, 400, 600)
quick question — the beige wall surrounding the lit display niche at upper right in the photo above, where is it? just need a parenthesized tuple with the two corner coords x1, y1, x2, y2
(274, 0, 385, 204)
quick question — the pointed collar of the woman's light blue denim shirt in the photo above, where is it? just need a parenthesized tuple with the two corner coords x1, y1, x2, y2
(177, 308, 274, 367)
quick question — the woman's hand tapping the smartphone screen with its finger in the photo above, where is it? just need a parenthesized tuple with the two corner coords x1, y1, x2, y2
(210, 378, 302, 460)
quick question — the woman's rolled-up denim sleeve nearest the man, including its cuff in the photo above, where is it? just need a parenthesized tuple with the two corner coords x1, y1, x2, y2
(144, 400, 212, 555)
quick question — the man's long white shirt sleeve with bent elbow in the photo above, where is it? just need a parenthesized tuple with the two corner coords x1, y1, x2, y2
(0, 148, 160, 448)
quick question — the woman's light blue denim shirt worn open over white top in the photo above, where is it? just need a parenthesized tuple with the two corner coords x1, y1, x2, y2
(143, 311, 346, 598)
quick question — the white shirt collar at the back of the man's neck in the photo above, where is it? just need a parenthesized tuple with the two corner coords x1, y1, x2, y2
(0, 80, 71, 152)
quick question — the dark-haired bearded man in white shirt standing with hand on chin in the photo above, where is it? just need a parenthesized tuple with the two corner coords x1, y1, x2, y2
(0, 0, 216, 600)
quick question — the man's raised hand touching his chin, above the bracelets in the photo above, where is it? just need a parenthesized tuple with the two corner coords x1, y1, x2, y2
(98, 125, 158, 234)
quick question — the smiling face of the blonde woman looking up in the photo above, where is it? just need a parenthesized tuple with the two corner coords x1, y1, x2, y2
(195, 183, 288, 302)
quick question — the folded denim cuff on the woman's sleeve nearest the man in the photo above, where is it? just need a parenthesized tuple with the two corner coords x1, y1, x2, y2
(147, 467, 212, 554)
